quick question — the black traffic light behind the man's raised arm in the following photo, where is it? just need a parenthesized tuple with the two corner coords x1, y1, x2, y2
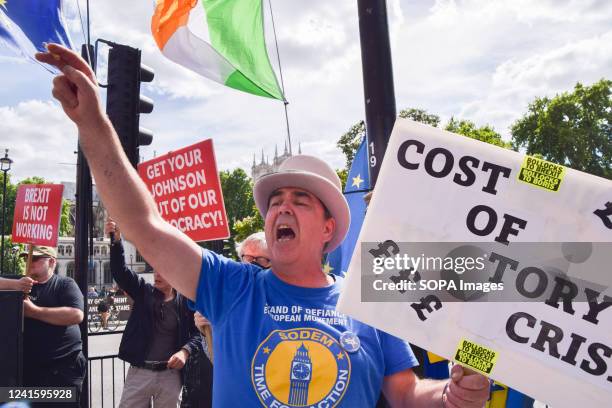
(106, 42, 155, 167)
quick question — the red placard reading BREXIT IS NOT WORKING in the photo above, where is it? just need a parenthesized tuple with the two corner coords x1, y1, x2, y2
(12, 184, 64, 247)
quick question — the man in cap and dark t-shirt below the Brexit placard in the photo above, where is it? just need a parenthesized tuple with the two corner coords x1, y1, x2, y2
(21, 246, 87, 407)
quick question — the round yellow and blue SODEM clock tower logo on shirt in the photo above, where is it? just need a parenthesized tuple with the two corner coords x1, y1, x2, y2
(251, 327, 351, 407)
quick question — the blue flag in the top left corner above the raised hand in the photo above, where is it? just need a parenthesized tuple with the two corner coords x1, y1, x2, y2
(0, 0, 72, 67)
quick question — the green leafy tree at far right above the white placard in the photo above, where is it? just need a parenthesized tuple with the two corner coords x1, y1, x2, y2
(511, 79, 612, 179)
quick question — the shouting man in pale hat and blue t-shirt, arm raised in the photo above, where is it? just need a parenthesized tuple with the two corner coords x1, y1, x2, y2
(37, 45, 489, 408)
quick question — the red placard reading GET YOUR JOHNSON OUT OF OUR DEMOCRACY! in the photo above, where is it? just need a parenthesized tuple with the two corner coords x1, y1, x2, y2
(138, 139, 229, 241)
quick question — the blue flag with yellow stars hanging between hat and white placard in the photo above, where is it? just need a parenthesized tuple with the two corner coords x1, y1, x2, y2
(324, 137, 370, 276)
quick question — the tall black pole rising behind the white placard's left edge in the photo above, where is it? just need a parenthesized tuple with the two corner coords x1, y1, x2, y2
(357, 0, 396, 188)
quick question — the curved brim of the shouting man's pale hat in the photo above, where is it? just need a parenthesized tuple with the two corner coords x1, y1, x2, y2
(253, 170, 351, 253)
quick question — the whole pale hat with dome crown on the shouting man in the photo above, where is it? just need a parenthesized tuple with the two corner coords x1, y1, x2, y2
(253, 155, 351, 252)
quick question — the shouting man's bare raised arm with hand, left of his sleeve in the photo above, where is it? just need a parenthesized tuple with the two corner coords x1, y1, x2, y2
(36, 44, 202, 300)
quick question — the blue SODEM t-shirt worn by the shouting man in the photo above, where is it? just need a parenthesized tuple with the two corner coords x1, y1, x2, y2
(195, 250, 417, 407)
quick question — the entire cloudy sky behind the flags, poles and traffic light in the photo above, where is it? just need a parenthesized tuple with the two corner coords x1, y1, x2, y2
(0, 0, 612, 182)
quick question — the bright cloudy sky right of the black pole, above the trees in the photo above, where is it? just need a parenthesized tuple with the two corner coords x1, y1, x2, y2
(393, 0, 612, 137)
